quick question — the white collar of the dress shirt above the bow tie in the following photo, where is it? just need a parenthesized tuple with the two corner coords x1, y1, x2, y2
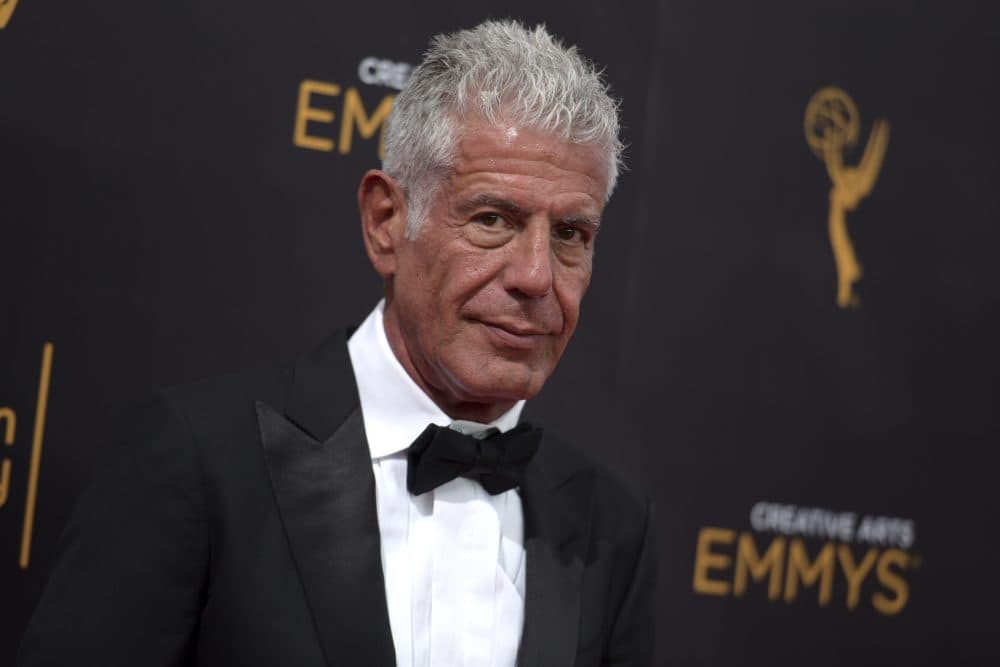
(347, 299, 524, 459)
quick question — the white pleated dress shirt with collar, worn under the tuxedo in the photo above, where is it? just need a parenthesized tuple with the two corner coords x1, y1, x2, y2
(347, 300, 525, 667)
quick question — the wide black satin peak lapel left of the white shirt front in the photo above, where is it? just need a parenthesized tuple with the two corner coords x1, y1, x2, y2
(257, 336, 396, 667)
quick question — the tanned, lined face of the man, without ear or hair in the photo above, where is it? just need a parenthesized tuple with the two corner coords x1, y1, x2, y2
(385, 117, 607, 420)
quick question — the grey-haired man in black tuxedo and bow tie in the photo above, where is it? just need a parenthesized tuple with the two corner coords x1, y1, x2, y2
(19, 22, 654, 667)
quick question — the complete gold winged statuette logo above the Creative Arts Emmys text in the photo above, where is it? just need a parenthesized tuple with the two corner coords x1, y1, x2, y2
(805, 86, 889, 308)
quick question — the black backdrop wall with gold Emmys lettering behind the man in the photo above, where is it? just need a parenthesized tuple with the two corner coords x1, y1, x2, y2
(0, 0, 1000, 666)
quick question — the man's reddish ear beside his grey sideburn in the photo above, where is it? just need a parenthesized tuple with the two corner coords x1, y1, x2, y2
(358, 169, 406, 278)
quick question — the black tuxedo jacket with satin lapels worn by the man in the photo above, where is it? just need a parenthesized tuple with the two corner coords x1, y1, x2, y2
(18, 335, 655, 667)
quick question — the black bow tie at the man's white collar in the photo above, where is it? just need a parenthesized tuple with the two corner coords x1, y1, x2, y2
(406, 424, 542, 496)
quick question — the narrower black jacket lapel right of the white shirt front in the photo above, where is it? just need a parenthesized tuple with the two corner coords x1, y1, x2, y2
(517, 436, 593, 667)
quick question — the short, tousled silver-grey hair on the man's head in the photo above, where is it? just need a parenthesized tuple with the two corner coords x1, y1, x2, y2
(382, 21, 623, 238)
